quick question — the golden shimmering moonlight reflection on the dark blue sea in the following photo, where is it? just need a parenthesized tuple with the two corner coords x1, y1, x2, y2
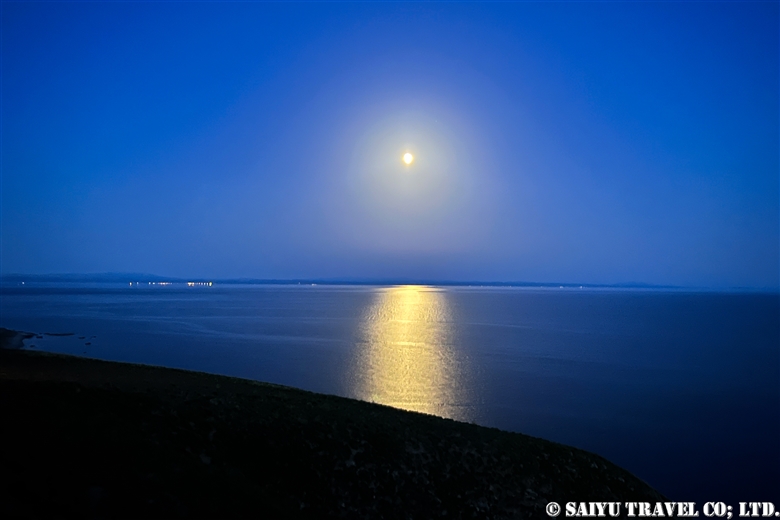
(353, 286, 471, 421)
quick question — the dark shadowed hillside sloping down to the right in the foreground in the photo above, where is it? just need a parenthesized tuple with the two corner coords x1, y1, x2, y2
(0, 329, 664, 519)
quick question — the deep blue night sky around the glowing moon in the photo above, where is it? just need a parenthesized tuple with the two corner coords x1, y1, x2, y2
(0, 2, 780, 289)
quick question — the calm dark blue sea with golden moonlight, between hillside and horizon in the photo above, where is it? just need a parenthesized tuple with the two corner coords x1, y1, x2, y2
(0, 285, 780, 505)
